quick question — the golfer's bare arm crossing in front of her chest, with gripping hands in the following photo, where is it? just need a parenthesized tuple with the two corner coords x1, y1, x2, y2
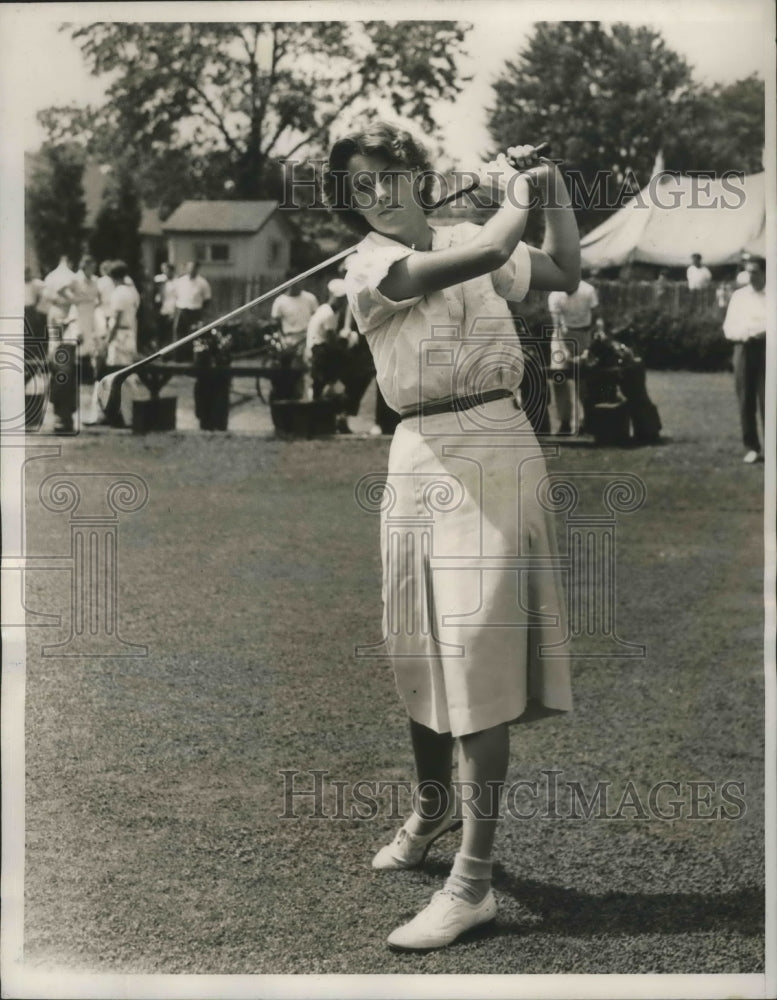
(380, 156, 547, 302)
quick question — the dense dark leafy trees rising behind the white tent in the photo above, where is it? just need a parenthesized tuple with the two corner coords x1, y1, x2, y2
(489, 21, 764, 230)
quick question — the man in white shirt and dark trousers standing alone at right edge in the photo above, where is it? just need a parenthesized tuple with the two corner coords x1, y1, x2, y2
(723, 257, 766, 464)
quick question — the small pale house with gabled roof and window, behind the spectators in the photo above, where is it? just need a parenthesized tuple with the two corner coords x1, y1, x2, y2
(162, 201, 293, 284)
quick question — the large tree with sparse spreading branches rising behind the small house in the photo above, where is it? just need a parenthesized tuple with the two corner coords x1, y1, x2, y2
(40, 21, 467, 211)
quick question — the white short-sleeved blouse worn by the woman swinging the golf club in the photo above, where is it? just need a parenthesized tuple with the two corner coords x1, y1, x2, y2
(345, 222, 531, 413)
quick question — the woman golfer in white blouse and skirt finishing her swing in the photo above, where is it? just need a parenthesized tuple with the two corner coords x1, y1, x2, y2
(324, 122, 580, 949)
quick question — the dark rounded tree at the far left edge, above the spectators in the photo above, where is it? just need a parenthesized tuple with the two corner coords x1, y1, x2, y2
(25, 144, 86, 274)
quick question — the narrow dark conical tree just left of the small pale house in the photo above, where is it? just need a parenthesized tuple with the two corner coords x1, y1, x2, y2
(89, 161, 142, 283)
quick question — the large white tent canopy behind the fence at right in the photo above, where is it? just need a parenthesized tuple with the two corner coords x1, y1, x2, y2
(580, 173, 766, 267)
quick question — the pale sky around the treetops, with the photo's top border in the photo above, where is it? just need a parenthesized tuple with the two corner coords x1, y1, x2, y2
(0, 0, 774, 165)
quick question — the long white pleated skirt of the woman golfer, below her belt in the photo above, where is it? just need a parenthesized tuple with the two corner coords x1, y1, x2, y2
(381, 398, 572, 736)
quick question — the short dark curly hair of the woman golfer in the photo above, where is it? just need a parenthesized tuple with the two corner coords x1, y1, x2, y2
(321, 121, 435, 236)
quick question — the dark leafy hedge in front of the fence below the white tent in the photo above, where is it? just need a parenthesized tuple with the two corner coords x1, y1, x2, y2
(608, 306, 731, 372)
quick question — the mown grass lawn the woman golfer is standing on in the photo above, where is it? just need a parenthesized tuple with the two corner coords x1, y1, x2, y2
(15, 373, 764, 974)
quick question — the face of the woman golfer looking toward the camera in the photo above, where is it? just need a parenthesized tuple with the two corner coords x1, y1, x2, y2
(348, 154, 424, 236)
